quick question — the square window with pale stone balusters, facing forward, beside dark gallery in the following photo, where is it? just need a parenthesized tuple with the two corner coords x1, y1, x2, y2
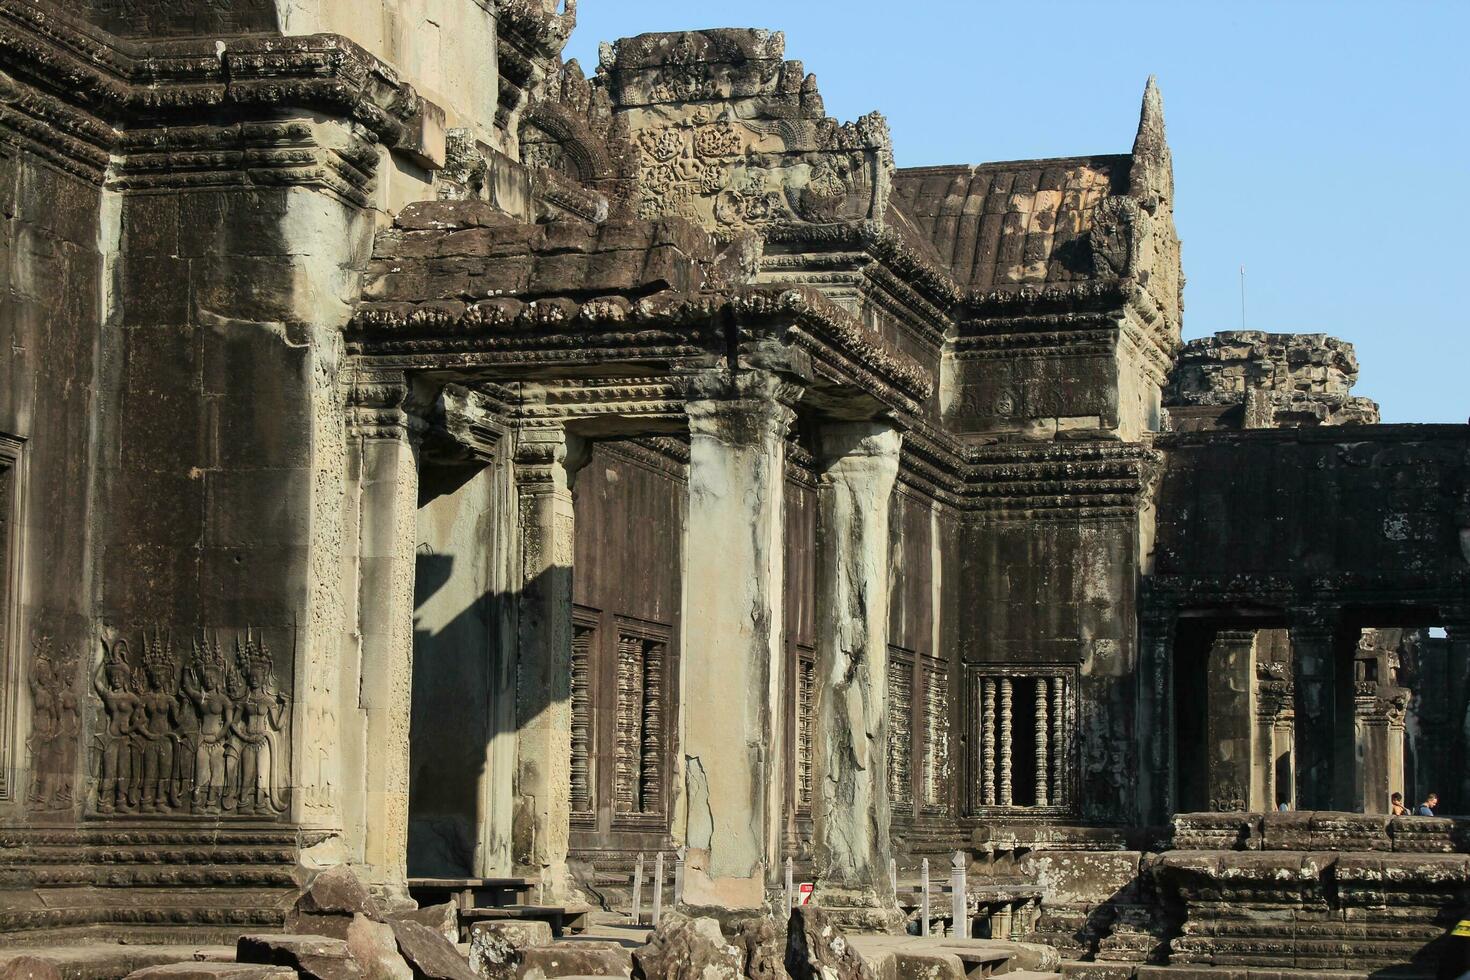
(966, 666, 1076, 815)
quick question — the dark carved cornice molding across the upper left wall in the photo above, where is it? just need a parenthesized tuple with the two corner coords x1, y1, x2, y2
(0, 0, 438, 183)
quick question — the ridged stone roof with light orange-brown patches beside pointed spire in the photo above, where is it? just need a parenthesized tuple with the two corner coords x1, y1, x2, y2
(894, 154, 1132, 292)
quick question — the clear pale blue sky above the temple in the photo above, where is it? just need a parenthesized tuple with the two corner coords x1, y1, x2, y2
(567, 0, 1470, 422)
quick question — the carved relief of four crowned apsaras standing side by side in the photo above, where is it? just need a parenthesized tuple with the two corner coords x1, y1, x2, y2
(91, 629, 291, 818)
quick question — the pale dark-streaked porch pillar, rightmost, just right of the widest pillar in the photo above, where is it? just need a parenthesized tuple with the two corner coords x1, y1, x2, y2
(811, 422, 903, 929)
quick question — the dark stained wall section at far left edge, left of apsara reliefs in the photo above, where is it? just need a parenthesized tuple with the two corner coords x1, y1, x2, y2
(0, 151, 106, 818)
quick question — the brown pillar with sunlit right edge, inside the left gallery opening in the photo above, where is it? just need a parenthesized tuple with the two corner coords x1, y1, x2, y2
(1205, 630, 1255, 811)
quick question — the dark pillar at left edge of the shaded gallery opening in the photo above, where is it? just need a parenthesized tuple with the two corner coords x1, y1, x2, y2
(1138, 605, 1179, 824)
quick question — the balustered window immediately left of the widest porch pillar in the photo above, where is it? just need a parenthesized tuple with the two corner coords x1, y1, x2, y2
(613, 619, 669, 823)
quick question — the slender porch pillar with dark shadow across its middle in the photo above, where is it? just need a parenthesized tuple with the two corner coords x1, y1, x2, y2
(512, 425, 587, 901)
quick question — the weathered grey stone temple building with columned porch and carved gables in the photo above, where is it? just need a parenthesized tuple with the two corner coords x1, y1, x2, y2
(0, 0, 1470, 977)
